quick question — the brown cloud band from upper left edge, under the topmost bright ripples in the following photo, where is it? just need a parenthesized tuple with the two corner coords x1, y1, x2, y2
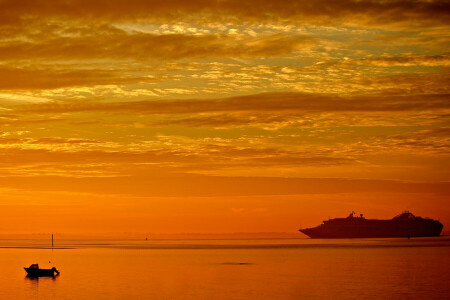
(0, 32, 314, 61)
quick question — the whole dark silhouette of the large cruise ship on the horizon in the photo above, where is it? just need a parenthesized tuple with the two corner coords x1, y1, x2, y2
(299, 211, 444, 238)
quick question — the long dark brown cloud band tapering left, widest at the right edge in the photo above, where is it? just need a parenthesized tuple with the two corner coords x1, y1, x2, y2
(14, 92, 450, 114)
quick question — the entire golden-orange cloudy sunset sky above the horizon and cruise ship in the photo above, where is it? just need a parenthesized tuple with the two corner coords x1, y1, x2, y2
(0, 0, 450, 237)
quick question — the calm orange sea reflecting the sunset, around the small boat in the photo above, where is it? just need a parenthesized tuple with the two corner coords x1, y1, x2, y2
(0, 237, 450, 300)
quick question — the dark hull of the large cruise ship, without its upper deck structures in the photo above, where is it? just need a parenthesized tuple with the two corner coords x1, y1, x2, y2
(299, 219, 443, 239)
